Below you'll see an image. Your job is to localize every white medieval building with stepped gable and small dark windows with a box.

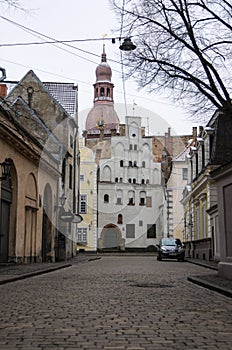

[98,117,166,250]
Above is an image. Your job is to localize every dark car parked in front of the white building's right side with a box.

[156,237,185,261]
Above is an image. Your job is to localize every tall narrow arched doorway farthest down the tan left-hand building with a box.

[42,184,52,262]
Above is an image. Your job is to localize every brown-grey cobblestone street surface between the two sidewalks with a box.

[0,256,232,350]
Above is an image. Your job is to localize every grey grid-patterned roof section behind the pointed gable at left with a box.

[43,82,77,117]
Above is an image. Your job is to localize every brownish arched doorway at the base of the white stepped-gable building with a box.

[101,224,122,250]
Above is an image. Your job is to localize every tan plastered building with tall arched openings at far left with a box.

[0,93,61,263]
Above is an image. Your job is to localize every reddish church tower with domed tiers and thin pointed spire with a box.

[85,44,119,138]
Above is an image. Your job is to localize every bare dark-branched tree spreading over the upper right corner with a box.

[111,0,232,116]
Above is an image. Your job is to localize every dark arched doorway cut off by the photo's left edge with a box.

[0,176,12,262]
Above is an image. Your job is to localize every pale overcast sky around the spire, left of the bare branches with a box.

[0,0,197,134]
